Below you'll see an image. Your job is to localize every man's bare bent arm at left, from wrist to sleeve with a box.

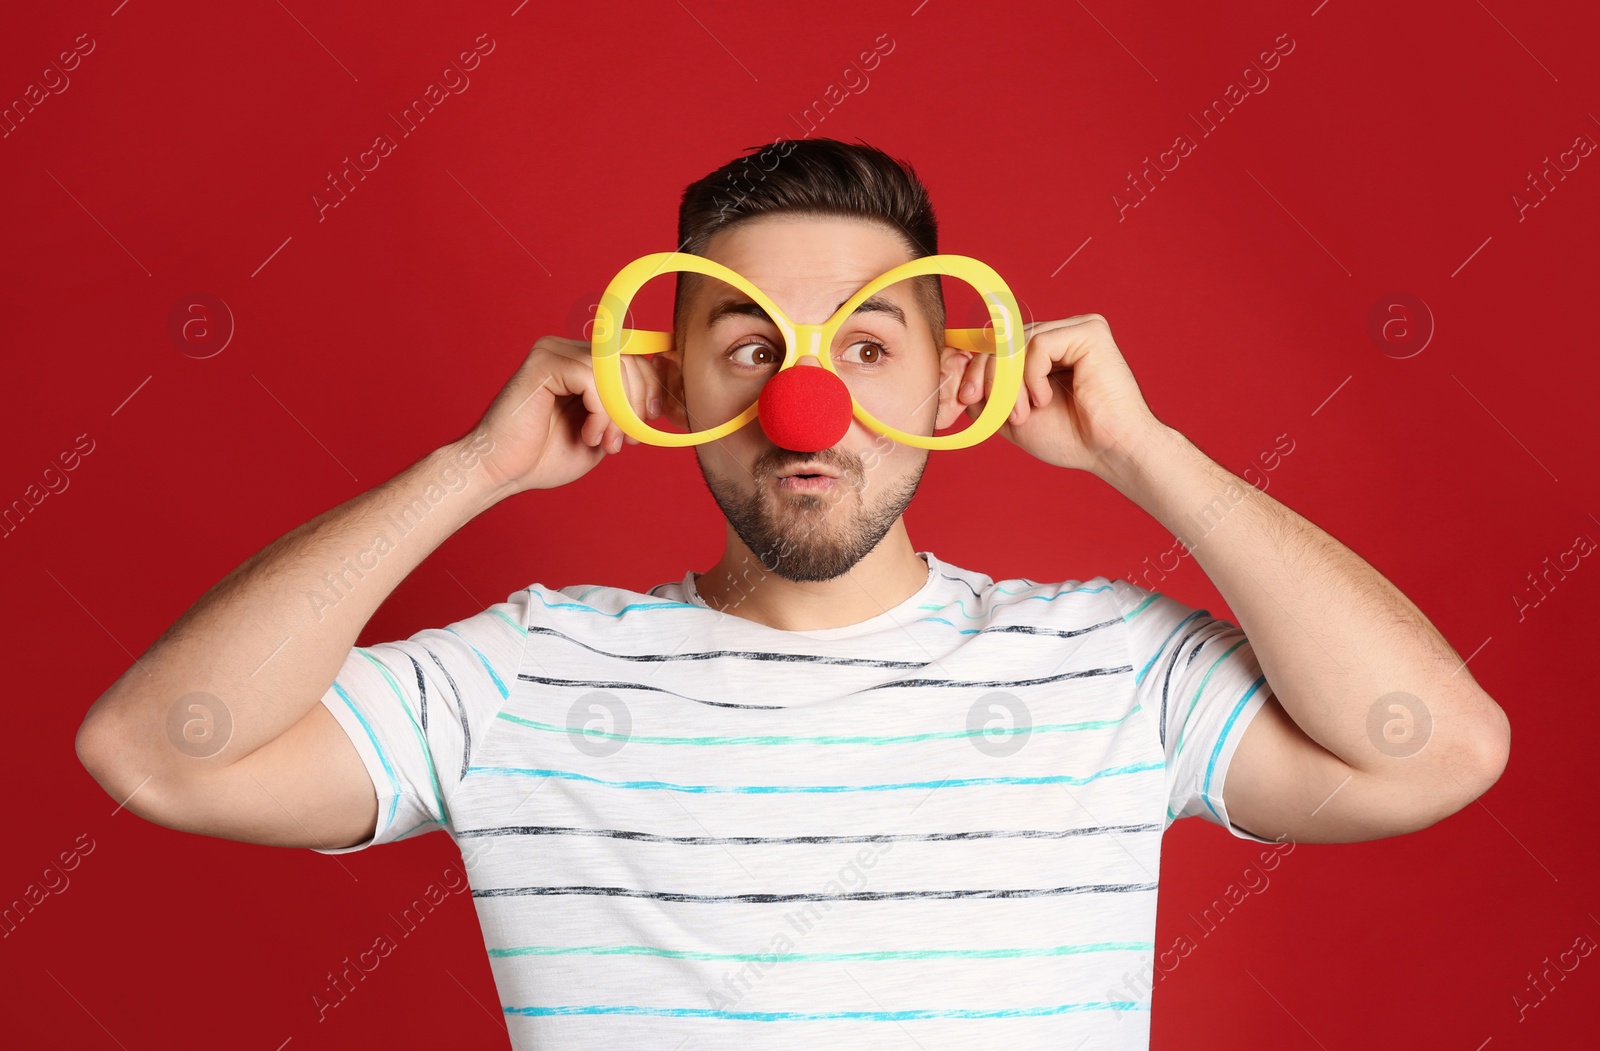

[77,432,501,848]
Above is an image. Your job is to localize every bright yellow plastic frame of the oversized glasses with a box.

[590,251,1024,450]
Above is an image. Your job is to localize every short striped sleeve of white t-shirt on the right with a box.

[1110,581,1274,843]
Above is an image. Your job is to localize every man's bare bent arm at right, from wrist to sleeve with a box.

[1096,418,1510,843]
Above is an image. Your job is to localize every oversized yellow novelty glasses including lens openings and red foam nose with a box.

[592,251,1022,451]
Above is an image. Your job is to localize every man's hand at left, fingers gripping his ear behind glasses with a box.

[475,336,669,496]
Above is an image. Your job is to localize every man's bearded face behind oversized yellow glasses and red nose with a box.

[656,216,965,581]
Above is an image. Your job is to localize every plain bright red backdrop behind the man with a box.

[0,0,1600,1051]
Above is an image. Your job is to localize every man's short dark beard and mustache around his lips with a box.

[694,450,928,582]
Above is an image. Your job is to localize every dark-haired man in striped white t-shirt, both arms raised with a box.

[78,139,1509,1051]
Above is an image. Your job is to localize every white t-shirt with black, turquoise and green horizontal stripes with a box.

[323,552,1270,1051]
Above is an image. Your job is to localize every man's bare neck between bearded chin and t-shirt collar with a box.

[694,522,928,632]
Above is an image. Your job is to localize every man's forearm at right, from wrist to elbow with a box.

[1098,424,1507,781]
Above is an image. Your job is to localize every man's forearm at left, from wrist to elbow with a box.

[80,425,498,771]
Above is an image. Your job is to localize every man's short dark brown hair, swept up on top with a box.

[672,139,944,349]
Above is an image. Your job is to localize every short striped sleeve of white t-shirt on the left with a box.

[312,589,530,854]
